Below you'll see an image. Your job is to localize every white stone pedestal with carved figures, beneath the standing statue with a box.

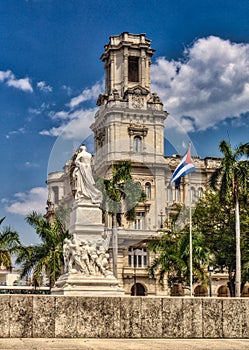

[52,201,124,296]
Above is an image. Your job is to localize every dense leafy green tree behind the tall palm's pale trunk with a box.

[192,190,249,296]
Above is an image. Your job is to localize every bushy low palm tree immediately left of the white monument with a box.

[17,212,69,288]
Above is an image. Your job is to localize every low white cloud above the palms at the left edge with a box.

[2,187,48,216]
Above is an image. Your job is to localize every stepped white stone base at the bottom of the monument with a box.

[51,273,124,296]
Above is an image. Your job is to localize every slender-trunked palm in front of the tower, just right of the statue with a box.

[98,161,146,277]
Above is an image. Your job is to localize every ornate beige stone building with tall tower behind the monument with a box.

[47,32,229,295]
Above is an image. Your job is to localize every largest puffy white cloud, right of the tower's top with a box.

[151,36,249,132]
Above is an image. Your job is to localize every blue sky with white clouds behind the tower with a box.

[0,0,249,244]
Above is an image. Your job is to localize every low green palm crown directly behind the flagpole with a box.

[148,207,210,287]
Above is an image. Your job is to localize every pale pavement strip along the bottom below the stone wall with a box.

[0,338,249,350]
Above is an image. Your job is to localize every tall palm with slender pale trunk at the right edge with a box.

[210,140,249,297]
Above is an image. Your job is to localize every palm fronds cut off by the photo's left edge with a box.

[0,217,21,271]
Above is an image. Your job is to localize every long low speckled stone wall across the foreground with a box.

[0,295,249,339]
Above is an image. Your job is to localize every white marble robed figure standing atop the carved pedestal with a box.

[72,145,102,204]
